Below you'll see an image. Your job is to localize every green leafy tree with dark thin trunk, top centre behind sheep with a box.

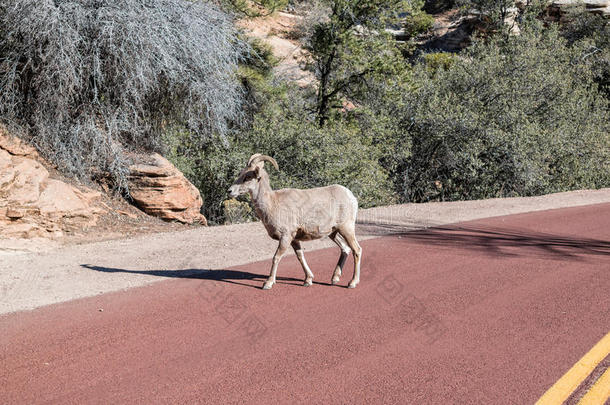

[306,0,414,126]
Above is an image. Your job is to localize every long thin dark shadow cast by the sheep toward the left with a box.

[80,264,330,289]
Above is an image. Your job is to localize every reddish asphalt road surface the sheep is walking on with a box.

[0,204,610,404]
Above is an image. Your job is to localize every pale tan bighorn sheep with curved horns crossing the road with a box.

[229,153,362,290]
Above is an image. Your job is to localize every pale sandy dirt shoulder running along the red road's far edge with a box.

[0,189,610,314]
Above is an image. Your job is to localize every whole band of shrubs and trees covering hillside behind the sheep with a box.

[0,0,610,223]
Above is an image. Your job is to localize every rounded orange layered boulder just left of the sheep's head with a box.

[129,153,207,225]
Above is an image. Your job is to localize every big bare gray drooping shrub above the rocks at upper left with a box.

[0,0,246,190]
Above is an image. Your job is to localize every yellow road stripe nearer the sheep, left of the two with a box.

[536,332,610,405]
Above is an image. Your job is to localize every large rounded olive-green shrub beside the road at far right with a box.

[404,27,610,201]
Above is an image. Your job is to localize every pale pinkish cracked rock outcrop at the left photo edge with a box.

[0,127,105,238]
